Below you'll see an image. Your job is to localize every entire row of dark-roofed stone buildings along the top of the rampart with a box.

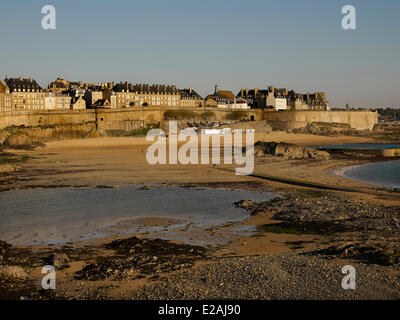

[0,77,329,111]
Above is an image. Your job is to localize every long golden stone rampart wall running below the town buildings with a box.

[0,106,378,131]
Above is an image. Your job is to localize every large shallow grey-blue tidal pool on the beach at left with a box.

[0,186,274,245]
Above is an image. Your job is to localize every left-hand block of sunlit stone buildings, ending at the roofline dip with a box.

[0,77,204,111]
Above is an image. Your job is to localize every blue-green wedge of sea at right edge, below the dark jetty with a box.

[336,160,400,189]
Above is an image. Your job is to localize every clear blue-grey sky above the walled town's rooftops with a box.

[0,0,400,107]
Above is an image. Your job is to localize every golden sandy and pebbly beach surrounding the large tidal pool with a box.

[0,132,400,299]
